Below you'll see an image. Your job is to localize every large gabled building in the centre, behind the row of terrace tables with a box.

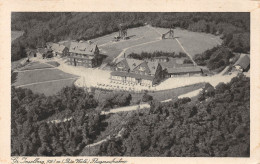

[111,58,164,86]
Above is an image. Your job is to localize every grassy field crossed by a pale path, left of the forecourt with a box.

[12,62,77,96]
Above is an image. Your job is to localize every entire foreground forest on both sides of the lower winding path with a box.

[11,75,250,157]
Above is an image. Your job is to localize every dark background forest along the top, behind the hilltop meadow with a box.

[11,12,250,61]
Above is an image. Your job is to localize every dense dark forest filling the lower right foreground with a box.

[97,75,250,157]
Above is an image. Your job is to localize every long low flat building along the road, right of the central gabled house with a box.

[166,66,203,77]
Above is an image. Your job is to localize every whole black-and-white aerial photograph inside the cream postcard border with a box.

[10,12,250,157]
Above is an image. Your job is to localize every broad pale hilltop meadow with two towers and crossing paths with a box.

[92,26,222,61]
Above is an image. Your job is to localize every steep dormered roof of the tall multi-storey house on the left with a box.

[69,41,98,55]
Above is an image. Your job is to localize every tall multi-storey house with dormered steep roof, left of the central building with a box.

[67,41,102,68]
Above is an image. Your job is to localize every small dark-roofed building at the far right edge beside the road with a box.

[233,54,250,72]
